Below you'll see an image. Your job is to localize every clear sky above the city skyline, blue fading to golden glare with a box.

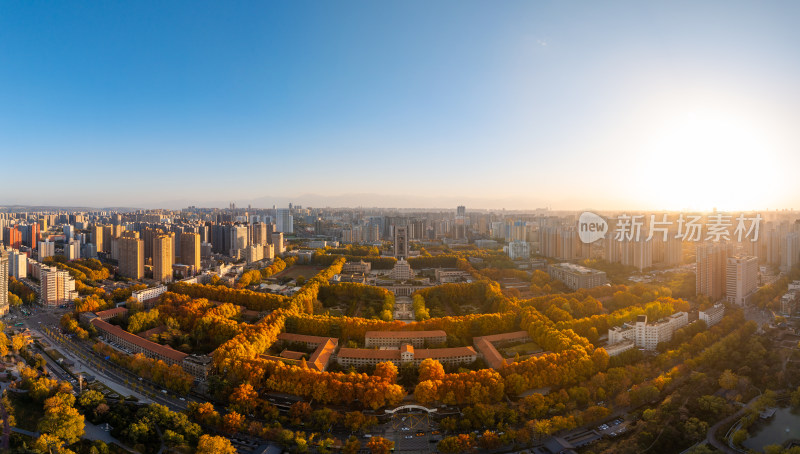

[0,1,800,209]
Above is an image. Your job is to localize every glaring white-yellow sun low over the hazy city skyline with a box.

[637,110,779,211]
